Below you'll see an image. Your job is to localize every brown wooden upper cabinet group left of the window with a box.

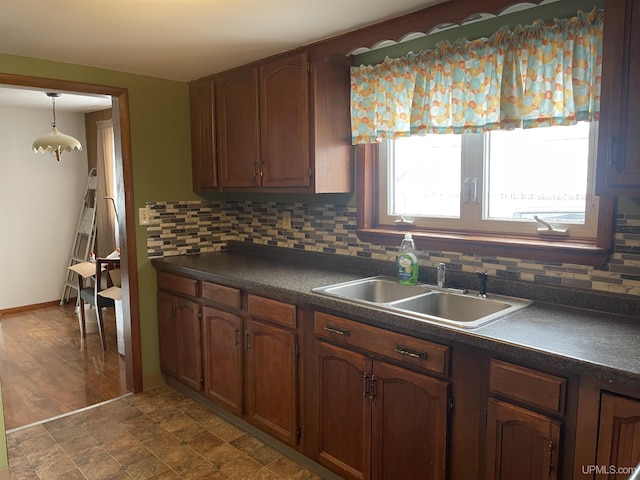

[190,50,353,193]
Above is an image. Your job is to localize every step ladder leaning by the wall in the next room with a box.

[60,168,98,305]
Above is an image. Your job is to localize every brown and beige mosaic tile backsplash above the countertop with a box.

[147,201,640,295]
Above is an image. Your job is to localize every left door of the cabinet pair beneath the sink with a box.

[318,342,370,479]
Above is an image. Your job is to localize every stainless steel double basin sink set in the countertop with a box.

[312,277,531,328]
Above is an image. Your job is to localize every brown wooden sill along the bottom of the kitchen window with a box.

[357,228,610,266]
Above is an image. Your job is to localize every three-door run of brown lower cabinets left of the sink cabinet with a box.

[158,272,300,446]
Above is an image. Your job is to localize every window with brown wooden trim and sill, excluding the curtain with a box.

[357,118,614,266]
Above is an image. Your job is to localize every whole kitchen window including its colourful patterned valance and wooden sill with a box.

[351,2,614,265]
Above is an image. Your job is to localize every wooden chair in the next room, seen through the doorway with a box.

[78,258,120,350]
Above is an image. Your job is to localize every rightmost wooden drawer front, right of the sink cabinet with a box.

[489,360,567,415]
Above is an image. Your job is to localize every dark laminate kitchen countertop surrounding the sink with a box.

[152,248,640,388]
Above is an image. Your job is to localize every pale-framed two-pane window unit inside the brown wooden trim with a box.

[378,122,598,239]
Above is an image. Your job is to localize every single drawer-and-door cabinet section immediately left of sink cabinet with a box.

[245,294,298,446]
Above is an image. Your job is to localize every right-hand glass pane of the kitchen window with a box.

[483,122,589,224]
